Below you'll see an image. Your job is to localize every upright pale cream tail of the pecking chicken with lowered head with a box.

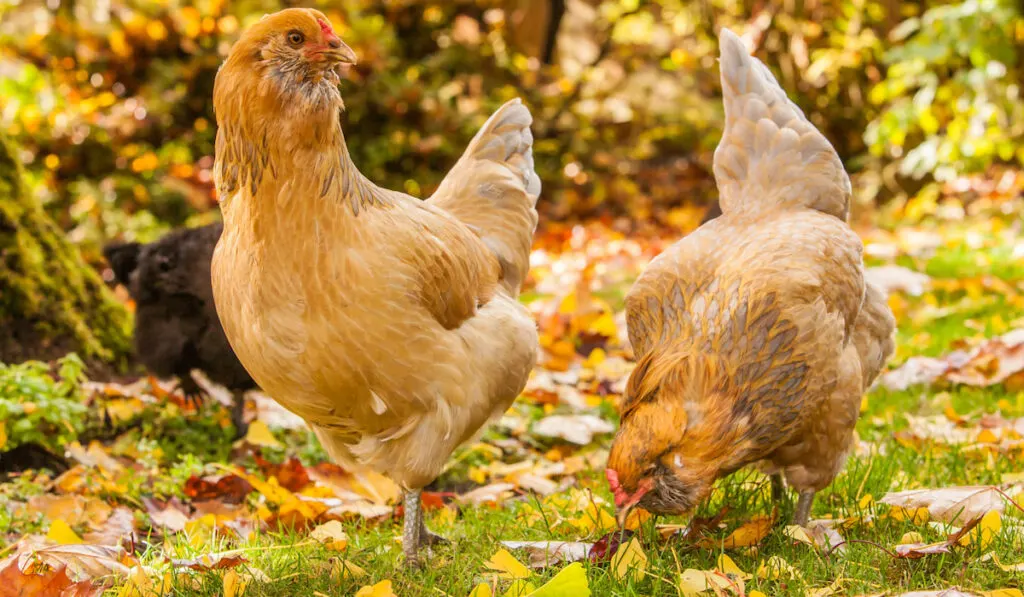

[715,28,852,220]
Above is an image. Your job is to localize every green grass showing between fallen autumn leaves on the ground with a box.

[8,216,1024,597]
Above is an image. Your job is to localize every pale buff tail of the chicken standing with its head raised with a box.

[427,98,541,296]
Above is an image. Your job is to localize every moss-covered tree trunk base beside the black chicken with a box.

[0,136,131,371]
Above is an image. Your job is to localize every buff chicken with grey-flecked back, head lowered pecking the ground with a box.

[606,29,895,524]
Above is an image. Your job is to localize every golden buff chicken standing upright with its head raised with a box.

[212,8,541,565]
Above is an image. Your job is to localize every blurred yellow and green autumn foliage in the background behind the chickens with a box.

[0,0,1024,247]
